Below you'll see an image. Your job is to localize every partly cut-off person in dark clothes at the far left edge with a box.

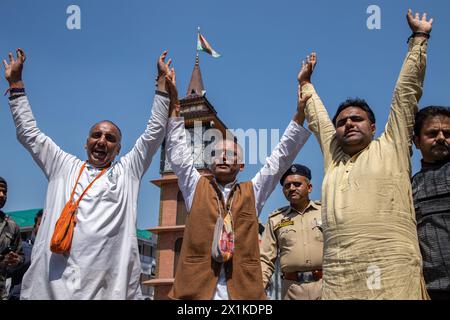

[0,177,24,300]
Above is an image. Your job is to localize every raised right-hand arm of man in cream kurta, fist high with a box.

[384,10,433,153]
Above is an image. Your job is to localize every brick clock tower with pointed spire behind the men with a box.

[144,54,227,300]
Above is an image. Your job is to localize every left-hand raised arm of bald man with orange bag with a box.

[3,49,76,180]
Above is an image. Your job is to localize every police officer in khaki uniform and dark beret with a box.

[261,164,323,300]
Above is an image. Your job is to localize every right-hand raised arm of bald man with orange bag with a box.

[121,51,172,179]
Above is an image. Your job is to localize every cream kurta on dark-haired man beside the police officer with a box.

[303,38,428,299]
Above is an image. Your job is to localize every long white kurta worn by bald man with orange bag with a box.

[5,48,169,299]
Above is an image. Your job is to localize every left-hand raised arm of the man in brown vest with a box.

[166,69,201,212]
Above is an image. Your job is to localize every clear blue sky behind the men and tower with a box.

[0,0,450,228]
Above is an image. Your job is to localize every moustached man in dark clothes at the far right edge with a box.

[412,106,450,300]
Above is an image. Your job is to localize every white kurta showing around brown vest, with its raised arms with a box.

[166,70,310,300]
